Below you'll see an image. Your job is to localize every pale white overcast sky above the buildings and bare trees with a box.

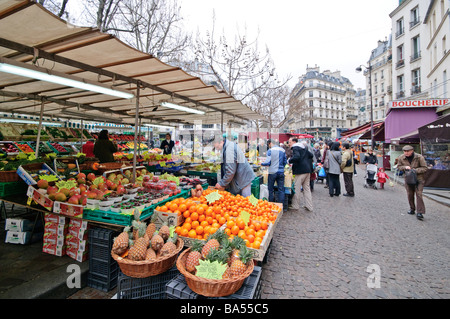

[178,0,398,89]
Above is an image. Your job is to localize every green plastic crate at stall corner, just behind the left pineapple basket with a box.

[83,205,156,226]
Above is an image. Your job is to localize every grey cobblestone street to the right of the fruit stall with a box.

[261,166,450,299]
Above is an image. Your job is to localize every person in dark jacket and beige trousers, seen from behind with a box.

[289,137,314,211]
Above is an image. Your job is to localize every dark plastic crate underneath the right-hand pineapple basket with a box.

[166,266,262,299]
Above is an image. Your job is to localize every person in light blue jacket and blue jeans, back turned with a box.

[261,139,287,204]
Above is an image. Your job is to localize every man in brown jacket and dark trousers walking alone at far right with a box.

[397,145,428,220]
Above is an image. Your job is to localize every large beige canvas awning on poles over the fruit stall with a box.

[0,0,264,125]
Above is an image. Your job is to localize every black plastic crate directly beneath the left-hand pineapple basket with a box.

[117,266,180,299]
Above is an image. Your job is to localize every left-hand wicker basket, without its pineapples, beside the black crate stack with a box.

[111,238,184,278]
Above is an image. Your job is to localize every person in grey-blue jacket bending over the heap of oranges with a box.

[214,134,256,197]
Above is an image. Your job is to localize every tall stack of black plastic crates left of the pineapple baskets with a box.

[87,227,120,292]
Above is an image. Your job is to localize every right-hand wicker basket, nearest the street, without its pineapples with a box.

[177,248,255,297]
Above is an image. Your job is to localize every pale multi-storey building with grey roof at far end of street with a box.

[284,66,358,137]
